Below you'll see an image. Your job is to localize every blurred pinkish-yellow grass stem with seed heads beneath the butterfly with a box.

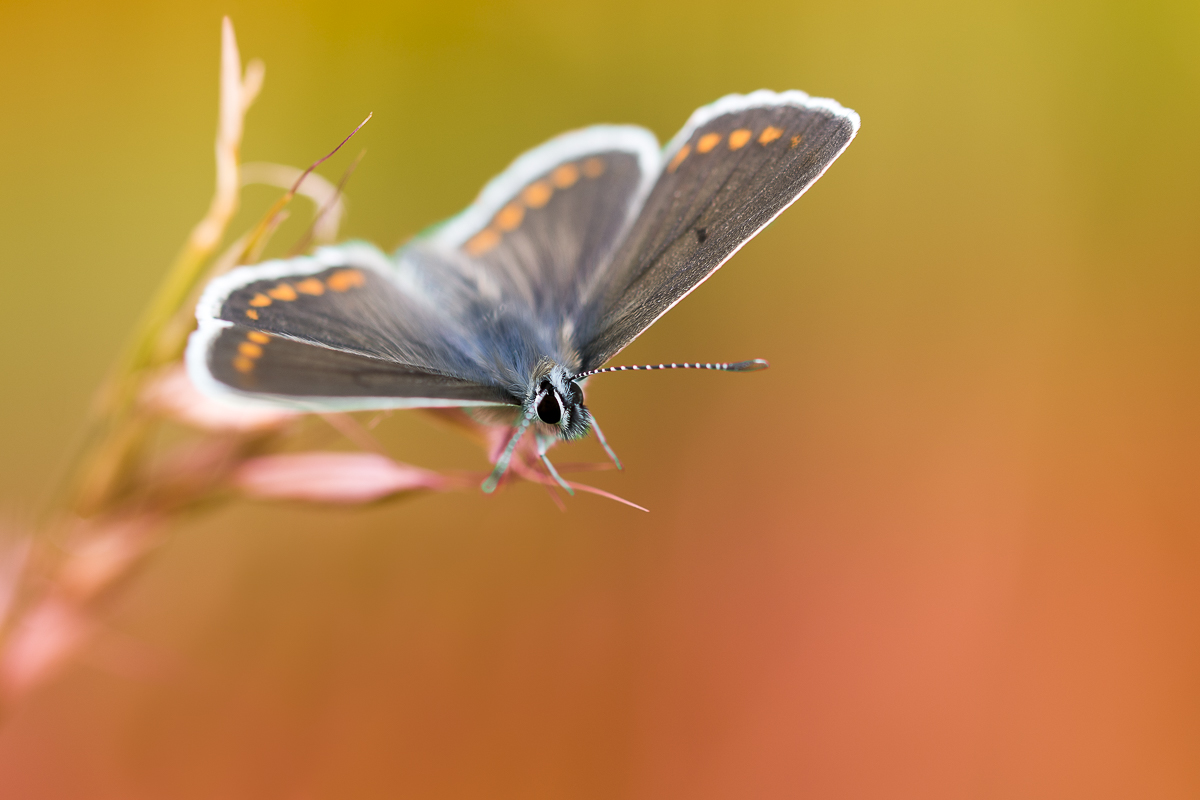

[0,18,638,708]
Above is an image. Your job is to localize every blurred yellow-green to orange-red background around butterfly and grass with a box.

[0,0,1200,799]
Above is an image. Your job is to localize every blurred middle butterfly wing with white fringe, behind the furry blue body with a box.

[398,125,661,381]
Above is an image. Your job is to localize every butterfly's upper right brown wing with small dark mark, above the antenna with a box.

[577,91,859,369]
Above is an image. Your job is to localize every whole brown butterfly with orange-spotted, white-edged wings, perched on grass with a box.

[186,90,859,492]
